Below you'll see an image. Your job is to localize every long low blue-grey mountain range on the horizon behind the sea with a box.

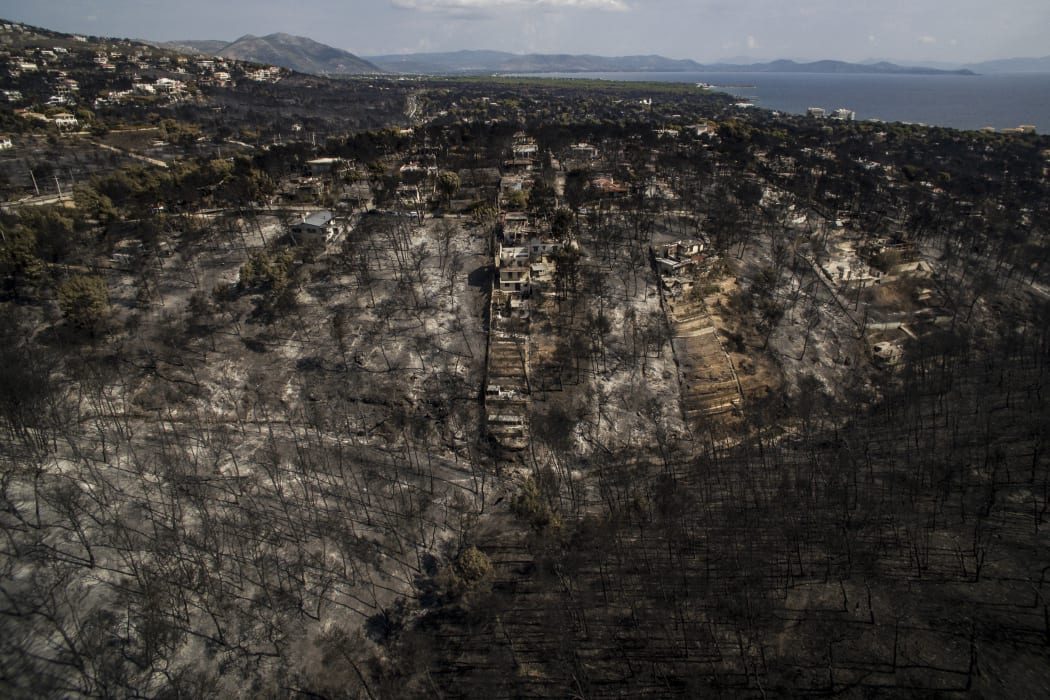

[368,51,972,75]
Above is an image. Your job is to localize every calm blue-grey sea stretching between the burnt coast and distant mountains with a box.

[514,72,1050,133]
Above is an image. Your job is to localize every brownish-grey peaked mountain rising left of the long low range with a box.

[162,34,383,76]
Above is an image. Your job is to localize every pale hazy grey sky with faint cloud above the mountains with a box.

[0,0,1050,62]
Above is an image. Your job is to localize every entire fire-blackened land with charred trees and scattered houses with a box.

[0,16,1050,699]
